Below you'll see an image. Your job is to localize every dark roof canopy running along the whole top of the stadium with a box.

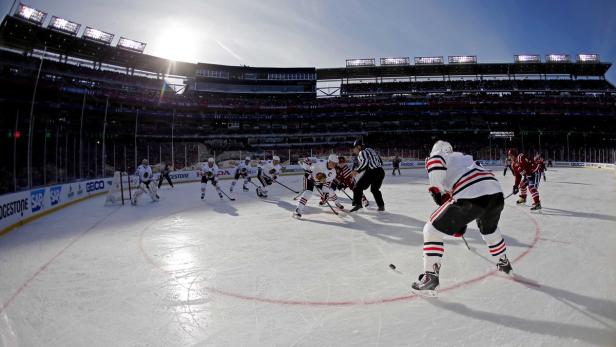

[0,15,612,81]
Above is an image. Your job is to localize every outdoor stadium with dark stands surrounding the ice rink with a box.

[0,4,616,346]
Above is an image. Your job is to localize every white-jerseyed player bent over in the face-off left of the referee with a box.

[293,154,344,218]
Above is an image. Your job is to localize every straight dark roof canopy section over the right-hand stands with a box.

[317,63,612,80]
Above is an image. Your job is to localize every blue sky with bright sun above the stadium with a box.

[0,0,616,82]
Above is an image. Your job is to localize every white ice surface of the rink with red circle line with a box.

[0,168,616,346]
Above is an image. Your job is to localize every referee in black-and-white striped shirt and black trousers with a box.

[350,139,385,212]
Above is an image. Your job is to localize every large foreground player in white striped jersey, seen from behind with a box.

[411,141,512,295]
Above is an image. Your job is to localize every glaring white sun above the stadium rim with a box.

[151,22,197,62]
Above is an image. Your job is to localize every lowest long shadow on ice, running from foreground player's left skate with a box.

[426,299,616,346]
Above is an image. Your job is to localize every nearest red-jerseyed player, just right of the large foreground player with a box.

[508,149,541,211]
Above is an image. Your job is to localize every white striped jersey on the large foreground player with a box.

[426,152,502,199]
